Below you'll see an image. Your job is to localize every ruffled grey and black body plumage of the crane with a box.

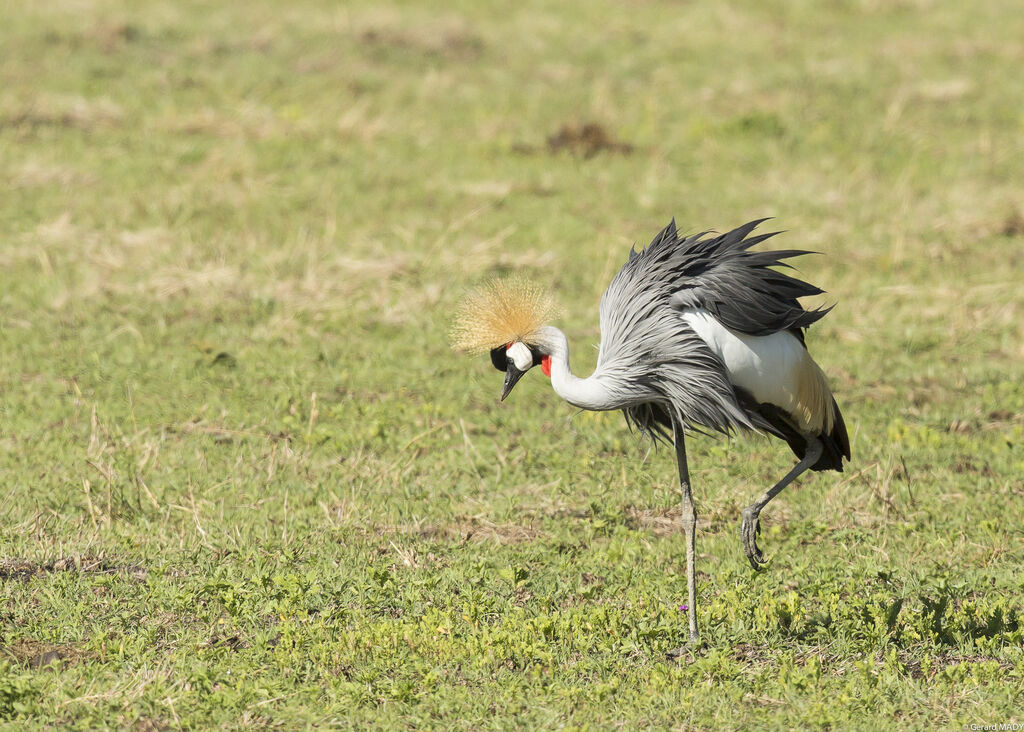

[596,219,850,470]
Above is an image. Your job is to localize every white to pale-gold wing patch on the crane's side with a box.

[682,308,835,433]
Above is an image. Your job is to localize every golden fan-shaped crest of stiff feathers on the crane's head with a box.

[451,276,558,353]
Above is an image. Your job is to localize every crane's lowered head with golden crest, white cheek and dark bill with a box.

[451,277,557,401]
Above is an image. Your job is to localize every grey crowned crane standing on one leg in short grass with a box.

[452,219,850,644]
